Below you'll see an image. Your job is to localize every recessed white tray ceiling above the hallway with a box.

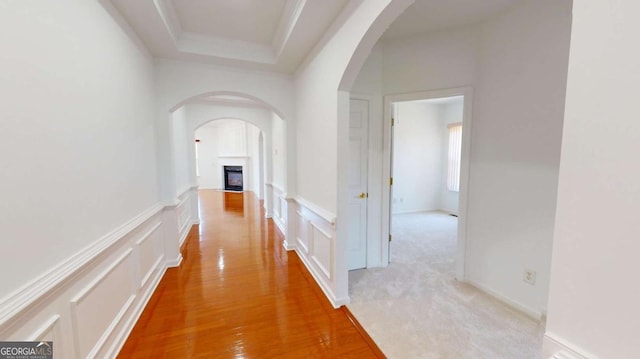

[109,0,350,73]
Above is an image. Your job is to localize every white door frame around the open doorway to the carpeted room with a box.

[381,86,473,281]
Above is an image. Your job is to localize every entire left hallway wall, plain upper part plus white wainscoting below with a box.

[0,0,194,358]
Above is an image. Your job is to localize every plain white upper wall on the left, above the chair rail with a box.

[0,0,158,297]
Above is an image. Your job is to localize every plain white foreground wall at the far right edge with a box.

[544,0,640,358]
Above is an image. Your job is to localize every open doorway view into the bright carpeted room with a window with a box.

[389,95,464,274]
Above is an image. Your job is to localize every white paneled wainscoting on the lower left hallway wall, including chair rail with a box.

[0,200,197,358]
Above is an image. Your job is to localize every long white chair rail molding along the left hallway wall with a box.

[0,204,163,332]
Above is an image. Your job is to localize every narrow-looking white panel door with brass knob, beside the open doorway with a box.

[349,99,369,270]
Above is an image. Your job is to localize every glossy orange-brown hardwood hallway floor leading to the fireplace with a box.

[119,190,384,359]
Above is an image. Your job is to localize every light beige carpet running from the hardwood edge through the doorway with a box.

[348,212,544,359]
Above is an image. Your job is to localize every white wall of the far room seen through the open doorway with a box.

[392,102,444,213]
